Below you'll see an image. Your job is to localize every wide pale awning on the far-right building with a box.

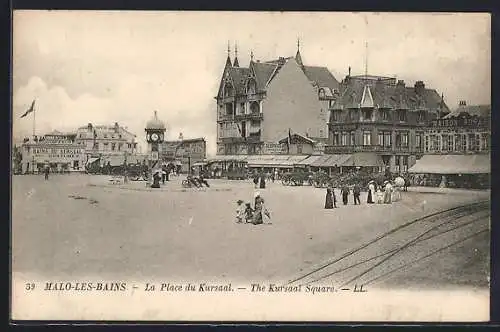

[408,154,491,174]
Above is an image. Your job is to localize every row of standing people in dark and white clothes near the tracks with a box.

[325,180,395,209]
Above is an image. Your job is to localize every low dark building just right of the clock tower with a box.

[161,138,207,173]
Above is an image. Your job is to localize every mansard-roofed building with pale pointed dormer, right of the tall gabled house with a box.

[325,74,449,173]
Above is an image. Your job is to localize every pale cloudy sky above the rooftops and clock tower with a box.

[12,11,491,155]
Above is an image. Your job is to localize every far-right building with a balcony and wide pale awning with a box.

[410,101,491,188]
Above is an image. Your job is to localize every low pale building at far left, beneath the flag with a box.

[21,131,86,174]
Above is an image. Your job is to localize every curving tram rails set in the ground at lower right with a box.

[287,201,490,288]
